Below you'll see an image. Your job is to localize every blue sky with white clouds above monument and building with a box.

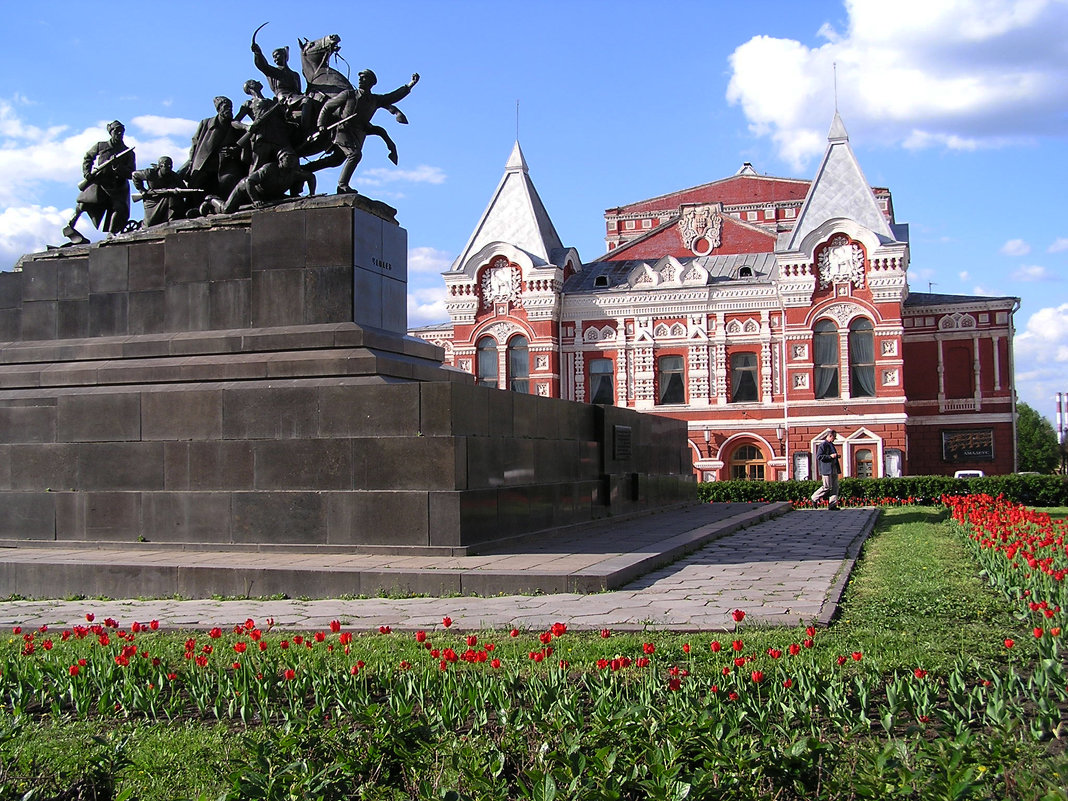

[0,0,1068,427]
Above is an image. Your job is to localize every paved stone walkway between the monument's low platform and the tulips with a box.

[0,508,878,631]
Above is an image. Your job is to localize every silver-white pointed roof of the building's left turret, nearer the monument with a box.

[452,141,563,270]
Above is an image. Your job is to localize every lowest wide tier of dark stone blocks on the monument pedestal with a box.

[0,381,692,549]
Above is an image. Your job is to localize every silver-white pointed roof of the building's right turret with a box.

[787,111,896,250]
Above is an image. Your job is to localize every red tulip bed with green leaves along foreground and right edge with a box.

[0,504,1068,801]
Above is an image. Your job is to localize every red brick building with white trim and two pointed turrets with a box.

[411,114,1019,481]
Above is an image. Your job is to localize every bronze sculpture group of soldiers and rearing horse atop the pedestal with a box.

[57,22,419,245]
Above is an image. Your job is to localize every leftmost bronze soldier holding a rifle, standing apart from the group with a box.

[63,120,137,245]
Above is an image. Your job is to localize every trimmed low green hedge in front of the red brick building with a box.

[697,474,1068,506]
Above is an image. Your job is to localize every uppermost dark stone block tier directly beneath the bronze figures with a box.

[0,198,407,342]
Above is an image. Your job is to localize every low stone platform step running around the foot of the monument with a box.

[0,503,790,598]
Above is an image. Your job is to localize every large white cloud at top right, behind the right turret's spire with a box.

[726,0,1068,169]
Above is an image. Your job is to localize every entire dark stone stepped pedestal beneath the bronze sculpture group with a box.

[0,197,693,568]
